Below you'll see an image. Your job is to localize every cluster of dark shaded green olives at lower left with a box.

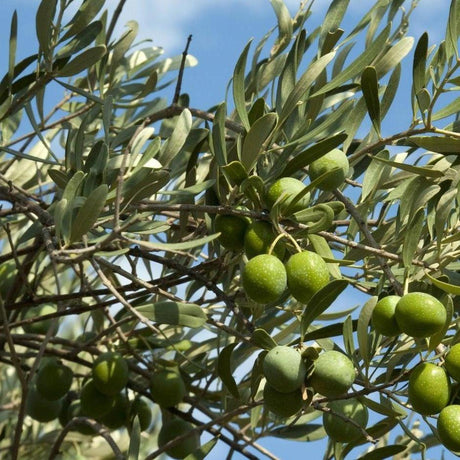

[26,351,200,458]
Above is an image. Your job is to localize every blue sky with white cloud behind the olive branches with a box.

[0,0,453,460]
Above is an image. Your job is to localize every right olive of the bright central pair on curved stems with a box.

[286,251,330,303]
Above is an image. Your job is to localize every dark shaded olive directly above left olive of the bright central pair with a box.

[244,220,286,259]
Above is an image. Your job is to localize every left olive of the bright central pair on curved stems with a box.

[241,254,287,303]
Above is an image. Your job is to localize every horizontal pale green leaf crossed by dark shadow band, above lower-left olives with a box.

[136,301,207,328]
